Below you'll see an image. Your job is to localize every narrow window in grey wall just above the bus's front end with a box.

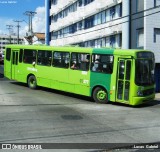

[136,28,144,49]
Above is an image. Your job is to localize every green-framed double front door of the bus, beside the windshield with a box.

[116,59,132,103]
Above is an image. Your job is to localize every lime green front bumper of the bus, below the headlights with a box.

[131,94,155,106]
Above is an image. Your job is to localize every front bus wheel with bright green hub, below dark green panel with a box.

[93,87,108,103]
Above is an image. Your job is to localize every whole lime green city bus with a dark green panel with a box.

[4,45,155,105]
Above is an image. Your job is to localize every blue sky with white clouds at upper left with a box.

[0,0,45,36]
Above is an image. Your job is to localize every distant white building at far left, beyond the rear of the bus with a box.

[0,35,24,54]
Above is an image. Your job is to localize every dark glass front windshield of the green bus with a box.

[135,59,154,85]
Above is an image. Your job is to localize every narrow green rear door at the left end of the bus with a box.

[11,50,18,80]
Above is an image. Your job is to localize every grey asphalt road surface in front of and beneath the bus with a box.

[0,66,160,149]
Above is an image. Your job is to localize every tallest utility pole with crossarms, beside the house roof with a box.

[24,11,37,44]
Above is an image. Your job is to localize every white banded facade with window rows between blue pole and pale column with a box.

[50,0,124,47]
